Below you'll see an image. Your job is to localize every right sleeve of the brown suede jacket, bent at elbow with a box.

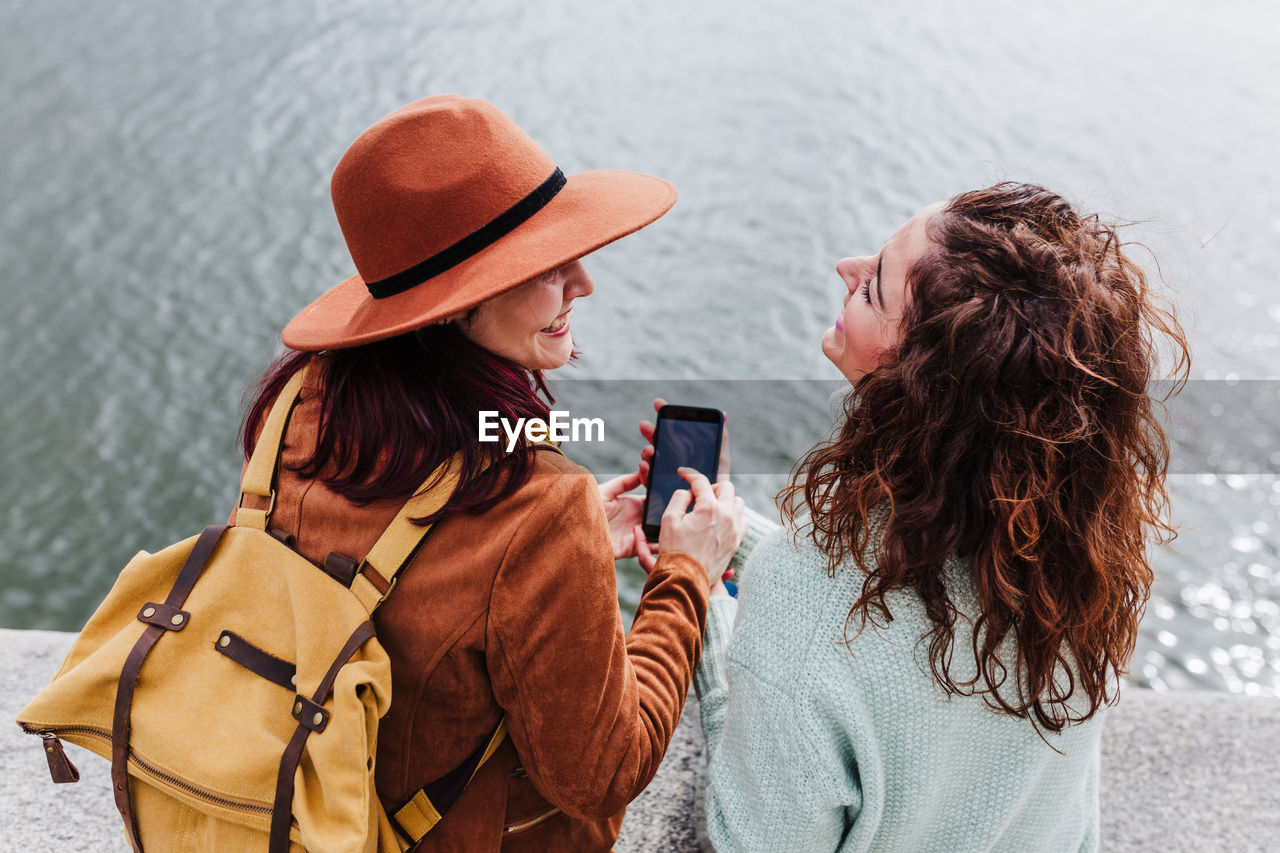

[486,474,707,820]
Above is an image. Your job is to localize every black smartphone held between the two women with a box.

[641,406,724,542]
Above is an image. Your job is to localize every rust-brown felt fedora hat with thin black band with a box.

[282,95,676,351]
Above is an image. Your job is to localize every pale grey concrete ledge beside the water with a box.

[0,629,1280,853]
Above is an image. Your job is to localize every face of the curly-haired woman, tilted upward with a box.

[822,201,943,384]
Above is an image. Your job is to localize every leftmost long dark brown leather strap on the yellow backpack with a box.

[111,525,227,853]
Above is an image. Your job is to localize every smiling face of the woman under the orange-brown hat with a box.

[449,260,595,370]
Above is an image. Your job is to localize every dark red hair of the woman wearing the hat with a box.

[242,324,554,523]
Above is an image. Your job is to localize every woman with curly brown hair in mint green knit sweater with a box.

[695,183,1189,853]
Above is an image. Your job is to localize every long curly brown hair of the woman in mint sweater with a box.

[781,183,1190,731]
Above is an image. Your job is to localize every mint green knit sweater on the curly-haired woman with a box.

[694,532,1101,853]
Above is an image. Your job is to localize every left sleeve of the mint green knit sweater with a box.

[694,558,861,850]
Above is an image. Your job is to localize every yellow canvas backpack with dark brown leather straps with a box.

[18,371,506,853]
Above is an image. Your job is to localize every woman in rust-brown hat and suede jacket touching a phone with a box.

[235,96,741,850]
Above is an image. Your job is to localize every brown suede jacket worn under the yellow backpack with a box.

[233,380,707,852]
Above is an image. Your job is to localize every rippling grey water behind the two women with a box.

[0,0,1280,695]
